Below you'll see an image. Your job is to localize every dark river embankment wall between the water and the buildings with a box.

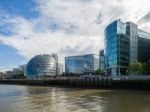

[0,79,150,90]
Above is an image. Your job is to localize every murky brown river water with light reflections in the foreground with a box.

[0,85,150,112]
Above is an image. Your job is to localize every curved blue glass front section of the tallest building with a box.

[105,21,129,76]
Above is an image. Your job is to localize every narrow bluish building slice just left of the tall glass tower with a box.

[99,50,106,70]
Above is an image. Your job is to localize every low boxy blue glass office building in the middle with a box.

[65,54,99,74]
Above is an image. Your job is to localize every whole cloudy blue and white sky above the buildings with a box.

[0,0,150,71]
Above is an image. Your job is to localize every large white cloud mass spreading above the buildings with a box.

[0,0,150,65]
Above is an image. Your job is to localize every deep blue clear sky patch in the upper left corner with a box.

[0,0,38,19]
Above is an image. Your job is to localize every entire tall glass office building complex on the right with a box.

[105,20,150,76]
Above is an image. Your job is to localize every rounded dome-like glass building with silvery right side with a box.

[25,54,58,77]
